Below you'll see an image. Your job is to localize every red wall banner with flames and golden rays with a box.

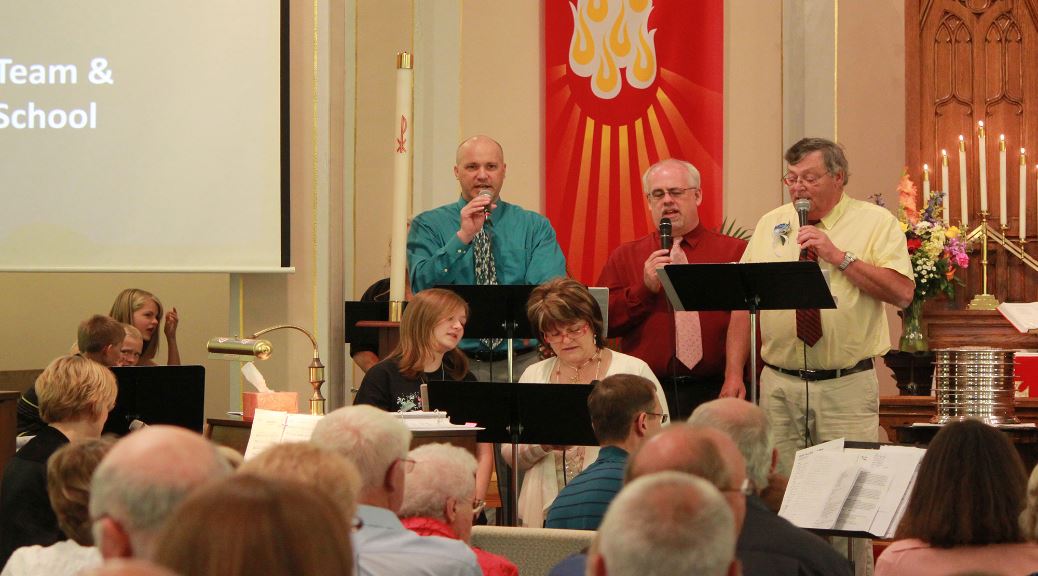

[543,0,725,283]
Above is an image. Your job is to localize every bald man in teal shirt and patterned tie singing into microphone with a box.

[407,136,566,381]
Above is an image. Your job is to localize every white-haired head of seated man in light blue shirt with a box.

[310,405,411,512]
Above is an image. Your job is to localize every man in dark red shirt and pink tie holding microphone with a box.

[598,159,746,420]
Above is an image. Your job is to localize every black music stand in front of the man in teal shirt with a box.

[436,284,537,382]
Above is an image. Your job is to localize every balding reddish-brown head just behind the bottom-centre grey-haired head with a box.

[627,424,748,532]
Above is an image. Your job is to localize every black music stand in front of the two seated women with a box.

[429,380,598,526]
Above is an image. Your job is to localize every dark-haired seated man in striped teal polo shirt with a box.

[545,374,667,530]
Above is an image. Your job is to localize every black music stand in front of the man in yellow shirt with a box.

[659,260,837,404]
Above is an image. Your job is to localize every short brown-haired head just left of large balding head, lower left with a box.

[47,438,114,546]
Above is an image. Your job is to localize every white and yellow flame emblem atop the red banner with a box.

[570,0,657,100]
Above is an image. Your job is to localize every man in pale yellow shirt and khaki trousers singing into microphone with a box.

[720,138,914,474]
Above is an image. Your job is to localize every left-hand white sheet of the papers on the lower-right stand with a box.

[779,439,862,529]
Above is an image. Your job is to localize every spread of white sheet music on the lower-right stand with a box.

[779,438,926,539]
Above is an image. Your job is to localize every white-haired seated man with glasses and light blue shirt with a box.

[310,405,482,576]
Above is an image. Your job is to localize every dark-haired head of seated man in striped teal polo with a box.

[588,374,666,452]
